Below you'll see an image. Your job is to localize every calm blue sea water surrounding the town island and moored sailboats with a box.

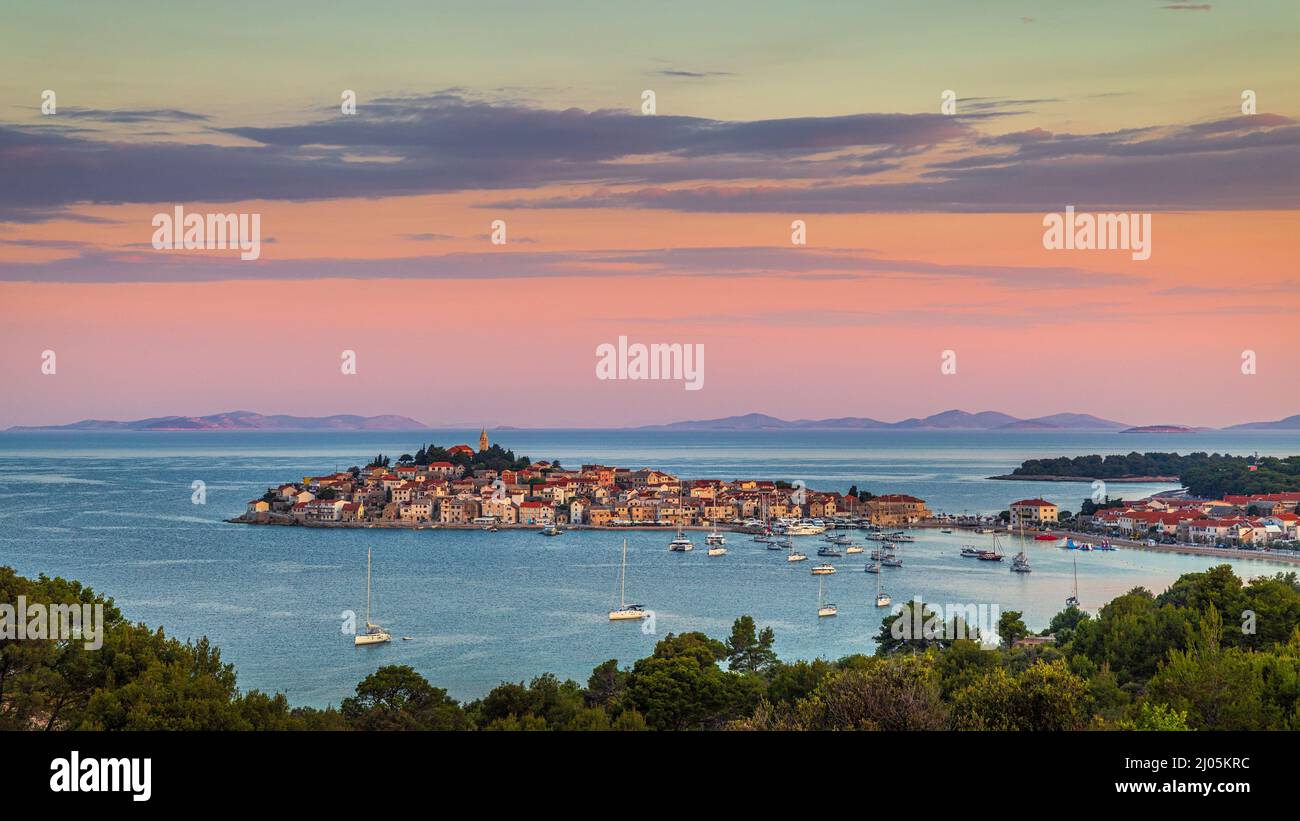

[0,430,1300,705]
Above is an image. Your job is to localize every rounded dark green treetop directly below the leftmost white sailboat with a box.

[339,664,469,730]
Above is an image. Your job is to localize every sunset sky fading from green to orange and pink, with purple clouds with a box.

[0,0,1300,427]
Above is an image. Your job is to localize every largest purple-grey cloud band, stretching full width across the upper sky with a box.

[0,91,1300,222]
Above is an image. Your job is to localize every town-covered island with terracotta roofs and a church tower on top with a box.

[228,430,931,530]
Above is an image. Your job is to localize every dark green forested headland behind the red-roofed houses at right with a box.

[1011,451,1300,499]
